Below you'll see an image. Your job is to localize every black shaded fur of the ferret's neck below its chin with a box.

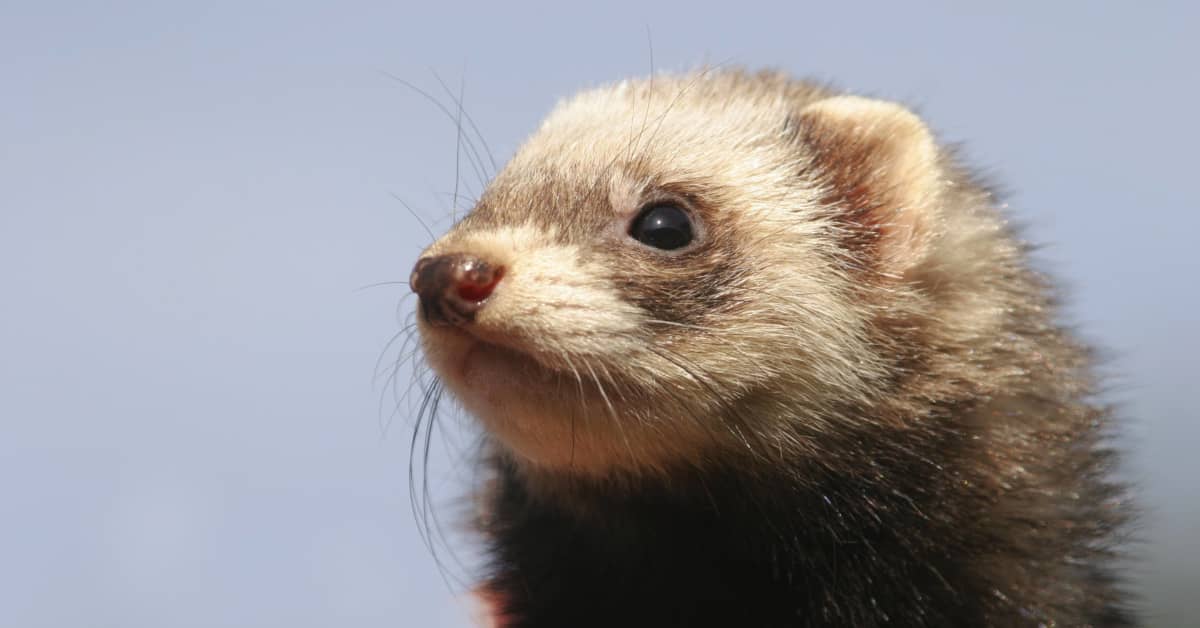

[488,451,985,628]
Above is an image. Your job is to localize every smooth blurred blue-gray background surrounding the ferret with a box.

[0,0,1200,628]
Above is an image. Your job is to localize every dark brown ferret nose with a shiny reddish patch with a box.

[408,253,504,325]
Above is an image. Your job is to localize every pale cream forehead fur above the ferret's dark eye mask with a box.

[497,71,823,192]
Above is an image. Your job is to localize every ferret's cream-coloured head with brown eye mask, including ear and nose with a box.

[412,72,1008,477]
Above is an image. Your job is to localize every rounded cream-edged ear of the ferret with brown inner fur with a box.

[788,96,941,275]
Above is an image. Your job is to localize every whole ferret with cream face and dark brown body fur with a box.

[410,70,1136,628]
